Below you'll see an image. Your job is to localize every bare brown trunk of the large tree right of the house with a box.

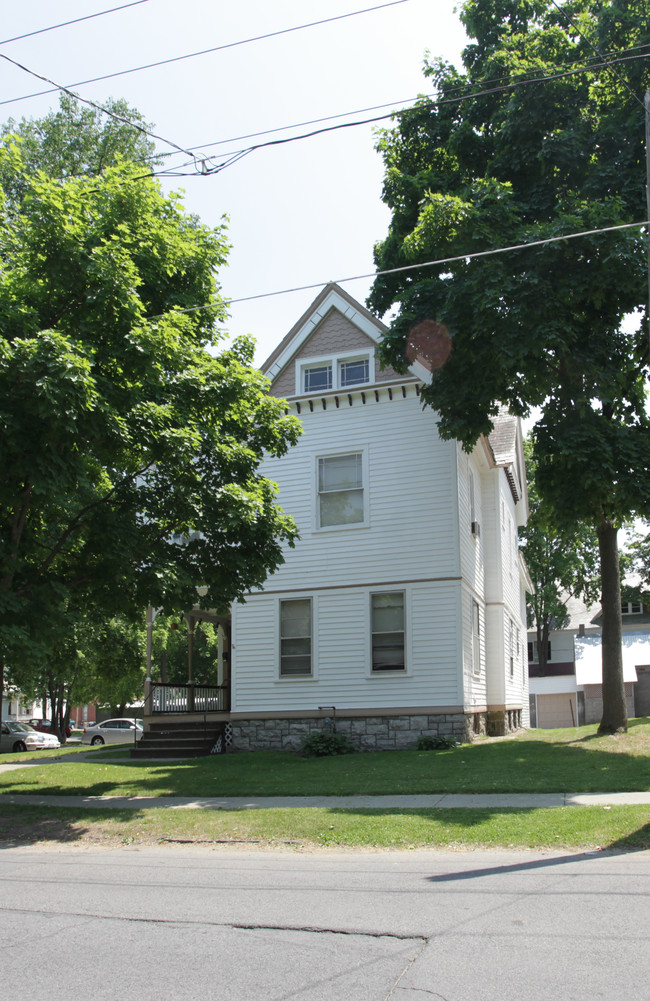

[598,515,627,734]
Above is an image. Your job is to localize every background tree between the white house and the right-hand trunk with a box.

[520,441,600,673]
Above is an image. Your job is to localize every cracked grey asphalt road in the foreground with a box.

[0,847,650,1001]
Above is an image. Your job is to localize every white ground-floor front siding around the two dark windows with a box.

[232,582,463,713]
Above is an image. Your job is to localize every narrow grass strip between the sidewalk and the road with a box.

[0,805,650,850]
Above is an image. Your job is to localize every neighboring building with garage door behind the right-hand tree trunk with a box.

[528,598,650,729]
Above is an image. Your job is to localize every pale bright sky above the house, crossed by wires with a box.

[0,0,465,362]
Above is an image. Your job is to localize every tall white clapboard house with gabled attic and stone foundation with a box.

[145,285,530,749]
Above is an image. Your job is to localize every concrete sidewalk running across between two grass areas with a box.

[0,793,650,810]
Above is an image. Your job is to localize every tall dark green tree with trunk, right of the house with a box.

[369,0,650,733]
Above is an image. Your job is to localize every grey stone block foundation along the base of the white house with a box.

[228,711,521,751]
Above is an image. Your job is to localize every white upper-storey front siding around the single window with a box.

[260,387,458,594]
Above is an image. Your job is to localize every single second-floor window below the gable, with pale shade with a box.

[317,451,366,529]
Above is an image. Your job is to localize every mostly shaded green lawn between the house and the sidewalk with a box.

[0,719,650,796]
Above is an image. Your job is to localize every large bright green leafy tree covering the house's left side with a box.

[0,141,298,712]
